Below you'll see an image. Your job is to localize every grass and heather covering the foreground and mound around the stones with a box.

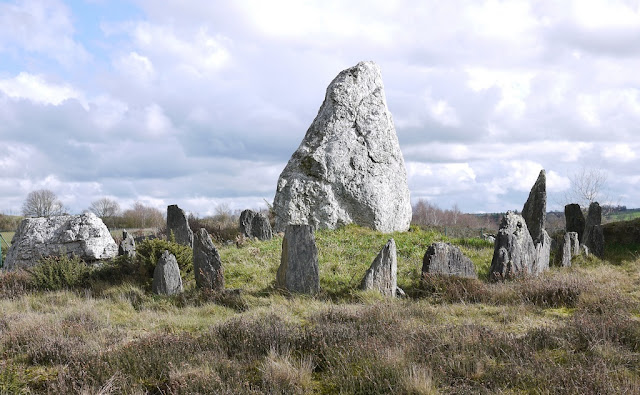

[0,226,640,394]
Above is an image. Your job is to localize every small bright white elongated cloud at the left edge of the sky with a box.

[0,72,88,109]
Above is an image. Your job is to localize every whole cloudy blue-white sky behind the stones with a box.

[0,0,640,216]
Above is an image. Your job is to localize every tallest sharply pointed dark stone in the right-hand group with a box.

[522,169,551,275]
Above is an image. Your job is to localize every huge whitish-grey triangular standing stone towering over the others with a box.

[273,62,411,232]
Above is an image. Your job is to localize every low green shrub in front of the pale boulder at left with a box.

[27,255,92,291]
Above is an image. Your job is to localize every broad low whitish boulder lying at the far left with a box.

[5,213,118,270]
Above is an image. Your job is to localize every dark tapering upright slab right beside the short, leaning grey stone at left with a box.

[193,228,224,290]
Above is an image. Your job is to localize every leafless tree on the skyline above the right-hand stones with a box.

[565,167,608,207]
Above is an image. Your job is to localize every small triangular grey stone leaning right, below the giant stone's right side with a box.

[360,239,398,296]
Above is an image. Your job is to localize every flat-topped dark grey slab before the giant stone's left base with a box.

[276,225,320,294]
